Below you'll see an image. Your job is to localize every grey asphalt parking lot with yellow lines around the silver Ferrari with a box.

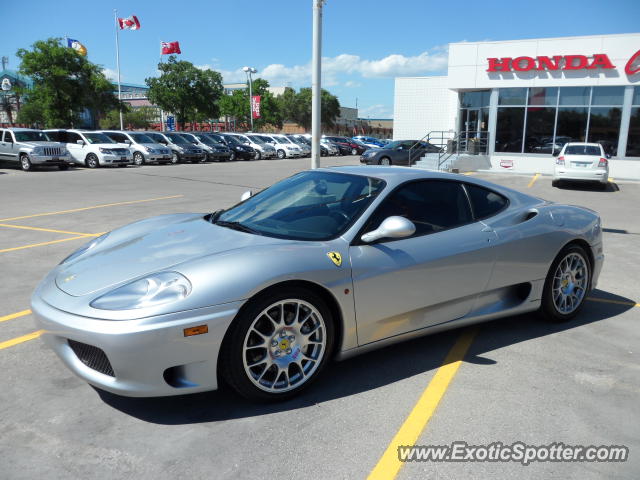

[0,157,640,479]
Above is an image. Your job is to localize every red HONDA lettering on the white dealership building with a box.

[487,53,616,72]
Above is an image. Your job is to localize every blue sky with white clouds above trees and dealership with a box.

[0,0,640,118]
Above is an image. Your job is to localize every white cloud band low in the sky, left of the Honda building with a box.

[196,46,448,87]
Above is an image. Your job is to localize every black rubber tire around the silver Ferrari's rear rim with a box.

[538,244,593,322]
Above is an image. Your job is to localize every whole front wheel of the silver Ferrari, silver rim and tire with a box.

[221,288,334,401]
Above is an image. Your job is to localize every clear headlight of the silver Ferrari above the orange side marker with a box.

[91,272,191,310]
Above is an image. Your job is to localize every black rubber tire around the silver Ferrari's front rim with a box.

[220,287,335,402]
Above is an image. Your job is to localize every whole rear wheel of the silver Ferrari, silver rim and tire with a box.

[540,244,591,322]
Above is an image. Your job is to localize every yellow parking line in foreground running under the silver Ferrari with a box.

[367,330,476,480]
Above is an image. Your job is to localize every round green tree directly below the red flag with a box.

[145,55,223,129]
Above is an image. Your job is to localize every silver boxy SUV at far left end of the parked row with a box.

[0,128,72,172]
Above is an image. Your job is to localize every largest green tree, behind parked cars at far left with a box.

[16,38,120,127]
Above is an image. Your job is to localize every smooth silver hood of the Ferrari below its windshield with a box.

[56,214,292,296]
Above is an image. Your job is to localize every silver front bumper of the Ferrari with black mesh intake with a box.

[31,293,242,397]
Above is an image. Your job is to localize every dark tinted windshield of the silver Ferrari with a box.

[214,171,385,240]
